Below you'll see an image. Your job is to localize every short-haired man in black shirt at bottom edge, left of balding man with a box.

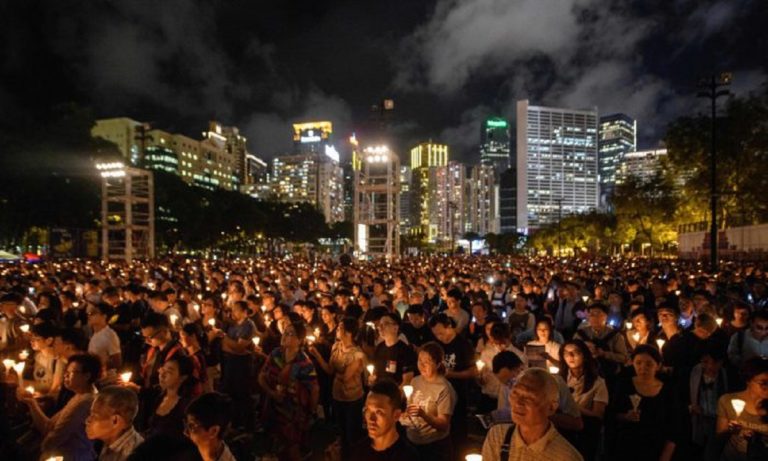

[348,379,419,461]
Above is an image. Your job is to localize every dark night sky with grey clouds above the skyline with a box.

[0,0,768,161]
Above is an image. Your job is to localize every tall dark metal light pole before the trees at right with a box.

[697,72,732,272]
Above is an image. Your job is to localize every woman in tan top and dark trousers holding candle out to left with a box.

[308,317,365,454]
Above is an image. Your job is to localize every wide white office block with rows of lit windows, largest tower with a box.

[516,100,598,233]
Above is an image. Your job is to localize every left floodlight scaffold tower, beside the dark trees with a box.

[96,162,155,262]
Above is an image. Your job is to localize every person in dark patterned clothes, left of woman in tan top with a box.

[259,320,320,461]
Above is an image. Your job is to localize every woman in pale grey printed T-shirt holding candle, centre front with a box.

[400,342,457,461]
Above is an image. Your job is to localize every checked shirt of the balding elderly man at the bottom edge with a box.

[483,424,584,461]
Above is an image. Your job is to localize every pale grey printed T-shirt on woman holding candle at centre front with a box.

[400,376,456,445]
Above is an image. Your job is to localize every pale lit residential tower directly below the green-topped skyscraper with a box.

[467,165,499,235]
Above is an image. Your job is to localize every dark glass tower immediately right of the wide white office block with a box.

[598,114,637,209]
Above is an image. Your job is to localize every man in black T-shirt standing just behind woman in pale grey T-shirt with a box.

[372,313,416,384]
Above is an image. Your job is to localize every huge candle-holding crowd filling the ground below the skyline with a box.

[0,256,768,461]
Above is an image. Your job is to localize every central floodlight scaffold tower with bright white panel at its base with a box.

[352,144,400,259]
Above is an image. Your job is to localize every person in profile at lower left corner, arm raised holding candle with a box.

[18,354,101,461]
